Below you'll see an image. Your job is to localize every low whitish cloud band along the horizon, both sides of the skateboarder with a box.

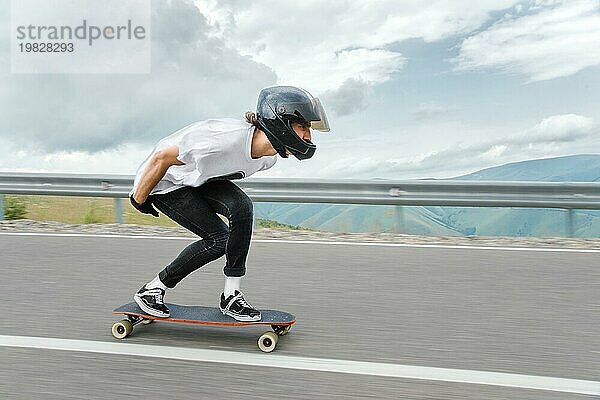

[0,114,600,179]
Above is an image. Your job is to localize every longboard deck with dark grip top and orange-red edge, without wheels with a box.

[113,303,296,326]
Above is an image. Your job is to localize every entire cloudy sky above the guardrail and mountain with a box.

[0,0,600,179]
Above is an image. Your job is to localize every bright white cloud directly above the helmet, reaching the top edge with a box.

[197,0,515,93]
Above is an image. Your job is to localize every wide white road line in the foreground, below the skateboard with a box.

[0,335,600,395]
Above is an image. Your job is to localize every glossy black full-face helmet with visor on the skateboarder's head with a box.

[256,86,329,160]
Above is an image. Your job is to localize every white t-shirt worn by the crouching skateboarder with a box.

[129,118,277,195]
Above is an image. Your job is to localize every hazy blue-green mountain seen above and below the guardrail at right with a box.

[255,154,600,237]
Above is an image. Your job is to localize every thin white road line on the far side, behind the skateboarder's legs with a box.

[0,232,600,253]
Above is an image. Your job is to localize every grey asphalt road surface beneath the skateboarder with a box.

[0,235,600,399]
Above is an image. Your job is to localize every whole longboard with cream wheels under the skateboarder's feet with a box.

[112,303,296,353]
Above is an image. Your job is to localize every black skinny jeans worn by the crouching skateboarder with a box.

[152,180,253,288]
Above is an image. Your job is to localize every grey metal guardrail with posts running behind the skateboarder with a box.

[0,172,600,231]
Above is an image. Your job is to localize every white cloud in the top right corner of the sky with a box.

[453,0,600,81]
